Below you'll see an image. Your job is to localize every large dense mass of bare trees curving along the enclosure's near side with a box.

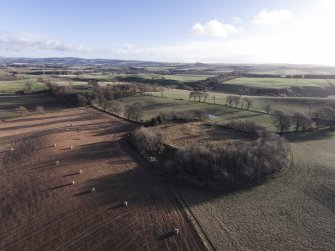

[170,128,289,189]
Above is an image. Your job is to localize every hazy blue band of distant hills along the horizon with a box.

[0,57,335,77]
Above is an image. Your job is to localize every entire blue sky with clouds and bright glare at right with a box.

[0,0,335,66]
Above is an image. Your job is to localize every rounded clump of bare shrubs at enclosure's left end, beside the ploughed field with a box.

[130,127,164,156]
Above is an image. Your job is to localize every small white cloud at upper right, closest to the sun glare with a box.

[252,9,293,26]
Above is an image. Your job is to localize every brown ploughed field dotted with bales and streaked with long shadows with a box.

[0,108,205,250]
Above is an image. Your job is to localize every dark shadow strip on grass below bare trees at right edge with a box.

[285,128,335,143]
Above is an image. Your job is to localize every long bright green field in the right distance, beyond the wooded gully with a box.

[225,78,330,89]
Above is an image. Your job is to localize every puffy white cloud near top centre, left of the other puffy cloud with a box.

[192,19,239,38]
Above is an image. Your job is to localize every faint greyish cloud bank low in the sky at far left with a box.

[0,32,94,53]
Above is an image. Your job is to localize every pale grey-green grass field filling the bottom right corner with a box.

[179,133,335,250]
